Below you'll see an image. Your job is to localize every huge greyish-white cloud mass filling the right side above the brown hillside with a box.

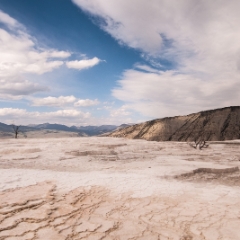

[72,0,240,117]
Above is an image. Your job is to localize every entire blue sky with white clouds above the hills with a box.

[0,0,240,126]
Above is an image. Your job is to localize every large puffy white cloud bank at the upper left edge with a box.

[0,10,71,99]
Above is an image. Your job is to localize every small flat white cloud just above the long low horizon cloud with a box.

[32,95,77,107]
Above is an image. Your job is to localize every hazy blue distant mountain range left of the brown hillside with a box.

[0,123,133,137]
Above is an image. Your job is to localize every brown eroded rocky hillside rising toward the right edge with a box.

[108,106,240,142]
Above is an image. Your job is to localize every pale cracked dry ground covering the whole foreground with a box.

[0,137,240,240]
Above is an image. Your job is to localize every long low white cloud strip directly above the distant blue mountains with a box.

[0,108,91,125]
